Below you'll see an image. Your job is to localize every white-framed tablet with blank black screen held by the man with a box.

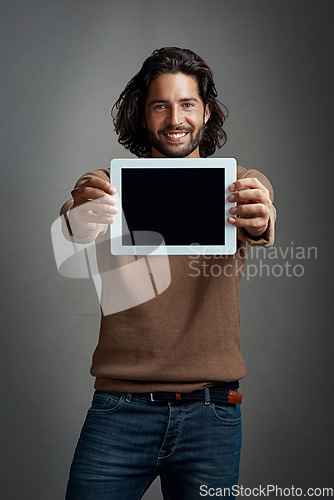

[110,158,237,255]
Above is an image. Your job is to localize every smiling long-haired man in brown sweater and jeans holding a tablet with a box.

[61,47,275,500]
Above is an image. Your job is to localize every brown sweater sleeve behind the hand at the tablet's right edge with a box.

[238,166,276,247]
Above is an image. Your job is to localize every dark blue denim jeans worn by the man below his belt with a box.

[66,389,241,500]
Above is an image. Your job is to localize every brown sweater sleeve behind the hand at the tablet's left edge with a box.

[60,169,110,243]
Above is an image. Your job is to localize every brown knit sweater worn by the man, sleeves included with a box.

[61,167,276,392]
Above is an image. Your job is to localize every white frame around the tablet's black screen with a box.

[110,158,237,255]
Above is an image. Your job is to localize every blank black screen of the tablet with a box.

[121,167,225,246]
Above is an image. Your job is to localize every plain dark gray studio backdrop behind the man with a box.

[0,0,334,500]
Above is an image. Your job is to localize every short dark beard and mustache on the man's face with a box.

[147,123,205,158]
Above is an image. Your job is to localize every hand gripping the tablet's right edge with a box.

[227,177,272,238]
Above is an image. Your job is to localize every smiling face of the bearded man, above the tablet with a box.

[143,73,211,158]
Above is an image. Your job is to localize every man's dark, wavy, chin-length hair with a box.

[111,47,228,158]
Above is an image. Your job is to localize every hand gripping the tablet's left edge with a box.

[68,177,118,238]
